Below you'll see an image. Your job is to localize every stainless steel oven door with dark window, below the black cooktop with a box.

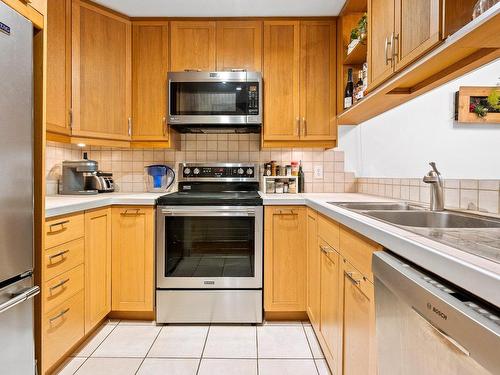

[156,206,263,289]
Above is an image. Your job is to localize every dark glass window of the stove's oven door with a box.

[165,217,255,277]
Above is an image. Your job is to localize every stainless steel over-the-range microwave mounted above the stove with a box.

[167,71,262,133]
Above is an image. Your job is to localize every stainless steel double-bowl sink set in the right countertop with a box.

[329,202,500,229]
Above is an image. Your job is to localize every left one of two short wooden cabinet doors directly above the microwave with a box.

[170,21,216,72]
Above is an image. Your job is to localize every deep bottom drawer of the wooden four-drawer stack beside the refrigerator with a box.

[42,290,84,369]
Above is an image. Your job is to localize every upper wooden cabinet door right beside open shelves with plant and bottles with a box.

[368,0,395,89]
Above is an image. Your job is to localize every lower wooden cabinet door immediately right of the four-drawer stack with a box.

[85,208,111,333]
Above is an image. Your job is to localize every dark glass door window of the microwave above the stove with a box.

[170,82,248,116]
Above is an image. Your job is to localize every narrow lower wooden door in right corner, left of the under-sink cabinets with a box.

[307,208,321,330]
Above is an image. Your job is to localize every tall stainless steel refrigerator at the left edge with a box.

[0,1,40,375]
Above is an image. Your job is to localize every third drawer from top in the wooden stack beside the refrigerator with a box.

[44,264,84,312]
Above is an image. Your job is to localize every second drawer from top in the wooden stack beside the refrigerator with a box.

[44,238,84,281]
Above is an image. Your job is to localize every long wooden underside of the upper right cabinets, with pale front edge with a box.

[337,4,500,125]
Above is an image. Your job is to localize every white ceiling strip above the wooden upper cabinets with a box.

[96,0,345,17]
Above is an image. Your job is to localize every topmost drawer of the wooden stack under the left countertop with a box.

[45,213,84,249]
